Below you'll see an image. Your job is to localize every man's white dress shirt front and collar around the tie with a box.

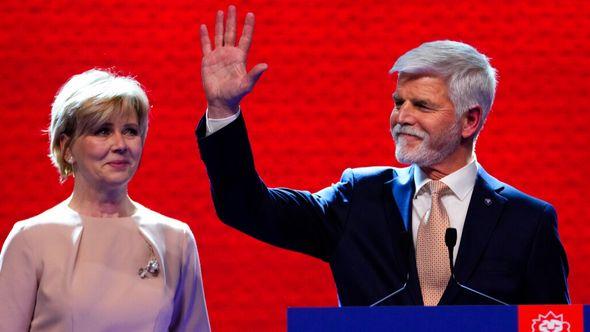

[412,156,477,262]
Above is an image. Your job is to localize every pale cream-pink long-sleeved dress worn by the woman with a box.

[0,201,210,332]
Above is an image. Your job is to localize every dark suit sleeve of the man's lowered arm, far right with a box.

[525,204,570,304]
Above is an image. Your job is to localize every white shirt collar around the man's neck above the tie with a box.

[413,155,478,200]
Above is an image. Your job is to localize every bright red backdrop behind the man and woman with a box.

[0,0,590,331]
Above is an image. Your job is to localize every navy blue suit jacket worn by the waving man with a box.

[196,116,569,305]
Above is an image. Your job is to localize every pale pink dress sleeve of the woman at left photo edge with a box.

[0,223,38,332]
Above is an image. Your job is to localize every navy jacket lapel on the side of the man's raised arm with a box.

[383,167,422,304]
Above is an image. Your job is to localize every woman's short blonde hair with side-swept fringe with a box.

[48,69,150,182]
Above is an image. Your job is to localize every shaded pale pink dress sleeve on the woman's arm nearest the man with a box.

[170,226,211,332]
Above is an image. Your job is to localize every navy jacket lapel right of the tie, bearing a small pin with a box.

[440,166,506,304]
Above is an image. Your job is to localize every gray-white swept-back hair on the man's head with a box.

[389,40,497,133]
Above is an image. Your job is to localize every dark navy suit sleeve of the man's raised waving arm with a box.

[196,116,353,261]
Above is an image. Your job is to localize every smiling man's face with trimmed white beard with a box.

[390,74,461,167]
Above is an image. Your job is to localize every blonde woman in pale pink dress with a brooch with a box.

[0,70,210,332]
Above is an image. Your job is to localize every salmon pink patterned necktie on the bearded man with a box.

[416,180,451,306]
